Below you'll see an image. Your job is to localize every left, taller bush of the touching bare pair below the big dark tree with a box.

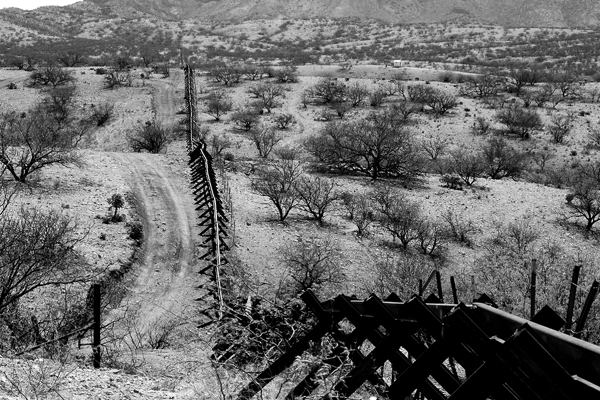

[252,159,302,222]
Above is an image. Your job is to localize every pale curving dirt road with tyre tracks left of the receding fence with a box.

[112,71,198,329]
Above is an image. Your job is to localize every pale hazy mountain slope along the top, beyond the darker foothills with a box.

[85,0,600,27]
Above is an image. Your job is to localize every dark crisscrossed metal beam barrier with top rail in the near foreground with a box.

[238,284,600,400]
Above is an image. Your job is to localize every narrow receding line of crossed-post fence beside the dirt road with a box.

[183,64,228,324]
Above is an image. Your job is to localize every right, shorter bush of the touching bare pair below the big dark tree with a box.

[296,175,340,224]
